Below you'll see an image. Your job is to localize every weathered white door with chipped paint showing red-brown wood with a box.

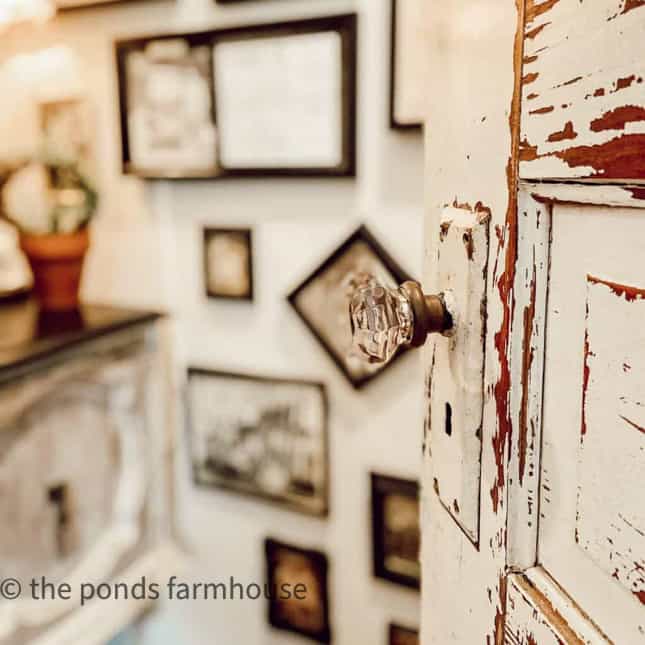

[422,0,645,645]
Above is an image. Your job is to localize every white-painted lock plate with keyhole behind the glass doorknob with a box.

[429,206,490,543]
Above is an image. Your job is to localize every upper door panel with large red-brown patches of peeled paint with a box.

[520,0,645,179]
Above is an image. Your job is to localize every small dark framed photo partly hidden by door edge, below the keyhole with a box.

[371,473,421,589]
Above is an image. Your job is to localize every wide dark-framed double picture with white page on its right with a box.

[115,14,357,179]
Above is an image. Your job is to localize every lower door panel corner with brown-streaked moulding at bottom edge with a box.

[504,568,610,645]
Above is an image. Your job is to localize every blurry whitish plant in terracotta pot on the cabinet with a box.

[1,157,97,311]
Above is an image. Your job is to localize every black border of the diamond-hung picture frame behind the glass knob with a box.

[287,225,411,389]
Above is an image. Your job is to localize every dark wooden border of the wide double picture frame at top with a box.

[115,14,357,179]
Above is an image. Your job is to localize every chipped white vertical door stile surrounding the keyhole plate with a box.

[421,0,521,645]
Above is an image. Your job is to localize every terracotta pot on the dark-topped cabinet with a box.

[20,228,90,311]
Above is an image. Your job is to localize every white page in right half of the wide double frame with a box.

[213,31,343,170]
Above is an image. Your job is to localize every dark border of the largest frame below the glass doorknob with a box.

[185,367,330,518]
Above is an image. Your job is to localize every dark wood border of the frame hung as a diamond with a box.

[287,225,411,389]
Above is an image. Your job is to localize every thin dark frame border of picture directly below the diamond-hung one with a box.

[185,367,330,518]
